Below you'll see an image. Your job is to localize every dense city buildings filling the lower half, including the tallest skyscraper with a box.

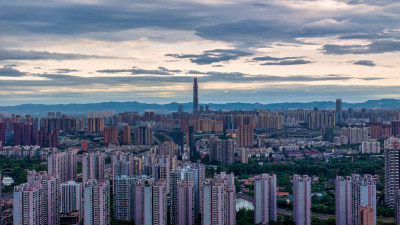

[0,78,400,225]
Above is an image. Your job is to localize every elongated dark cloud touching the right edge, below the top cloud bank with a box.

[322,40,400,55]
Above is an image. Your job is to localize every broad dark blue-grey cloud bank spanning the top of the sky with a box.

[0,1,398,49]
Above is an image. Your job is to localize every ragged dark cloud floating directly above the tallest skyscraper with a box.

[166,49,253,65]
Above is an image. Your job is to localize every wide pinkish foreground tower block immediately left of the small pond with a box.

[200,173,236,225]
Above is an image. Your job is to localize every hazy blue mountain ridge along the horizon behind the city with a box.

[0,99,400,115]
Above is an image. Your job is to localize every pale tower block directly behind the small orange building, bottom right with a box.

[351,174,377,225]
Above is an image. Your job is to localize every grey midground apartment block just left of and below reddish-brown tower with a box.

[209,137,235,165]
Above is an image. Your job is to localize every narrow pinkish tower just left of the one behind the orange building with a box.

[335,176,352,225]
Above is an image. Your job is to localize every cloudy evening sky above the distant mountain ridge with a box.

[0,0,400,105]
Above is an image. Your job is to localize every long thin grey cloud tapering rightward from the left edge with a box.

[0,49,111,60]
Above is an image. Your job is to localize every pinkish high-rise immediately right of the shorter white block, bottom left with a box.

[83,179,110,225]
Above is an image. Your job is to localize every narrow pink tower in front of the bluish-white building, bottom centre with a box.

[177,180,195,225]
